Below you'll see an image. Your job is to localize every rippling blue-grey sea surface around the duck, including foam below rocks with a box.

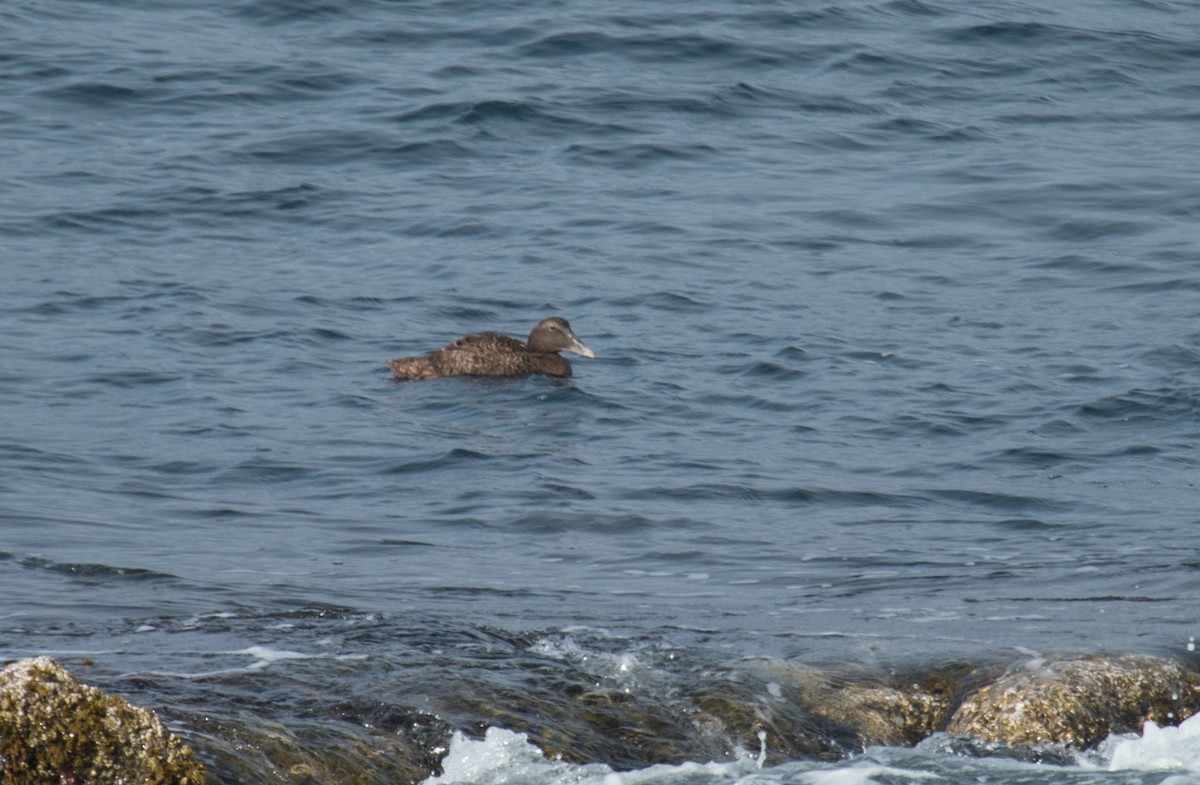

[0,0,1200,785]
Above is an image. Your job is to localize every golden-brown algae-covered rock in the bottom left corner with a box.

[0,657,205,785]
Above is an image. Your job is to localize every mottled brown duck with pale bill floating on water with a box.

[388,316,595,382]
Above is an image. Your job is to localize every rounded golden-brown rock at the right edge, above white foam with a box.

[946,654,1200,749]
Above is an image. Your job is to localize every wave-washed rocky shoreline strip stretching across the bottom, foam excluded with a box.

[9,654,1200,785]
